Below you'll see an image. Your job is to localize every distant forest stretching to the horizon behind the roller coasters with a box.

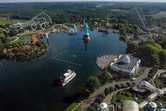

[0,2,166,24]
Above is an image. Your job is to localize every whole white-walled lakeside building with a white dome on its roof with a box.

[110,55,141,75]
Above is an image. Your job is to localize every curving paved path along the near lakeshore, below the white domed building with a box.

[81,68,150,111]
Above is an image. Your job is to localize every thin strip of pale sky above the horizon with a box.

[0,0,166,3]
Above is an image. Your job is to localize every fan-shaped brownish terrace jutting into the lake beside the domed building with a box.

[96,54,118,70]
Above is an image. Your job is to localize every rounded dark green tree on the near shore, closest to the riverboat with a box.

[85,76,101,92]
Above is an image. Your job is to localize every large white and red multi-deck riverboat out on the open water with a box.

[60,70,76,86]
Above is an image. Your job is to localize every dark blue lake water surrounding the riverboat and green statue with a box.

[0,30,126,111]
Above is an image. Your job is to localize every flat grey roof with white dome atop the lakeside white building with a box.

[112,55,139,71]
